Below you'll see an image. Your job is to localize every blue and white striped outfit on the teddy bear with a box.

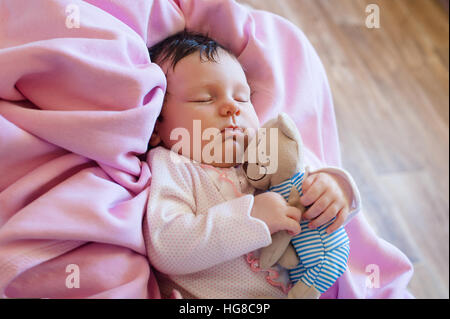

[269,172,350,293]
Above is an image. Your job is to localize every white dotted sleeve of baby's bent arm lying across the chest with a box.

[144,152,271,275]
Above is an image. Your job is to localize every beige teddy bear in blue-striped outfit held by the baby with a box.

[243,113,350,299]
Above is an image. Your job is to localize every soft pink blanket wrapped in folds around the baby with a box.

[0,0,412,298]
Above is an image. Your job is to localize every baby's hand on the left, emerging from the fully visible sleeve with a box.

[250,192,302,235]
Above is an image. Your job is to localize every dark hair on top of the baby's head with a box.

[148,30,234,68]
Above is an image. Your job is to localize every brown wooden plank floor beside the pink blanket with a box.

[239,0,449,298]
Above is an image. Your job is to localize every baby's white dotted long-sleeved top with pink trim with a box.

[144,147,362,298]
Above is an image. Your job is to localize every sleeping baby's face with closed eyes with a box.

[157,49,259,167]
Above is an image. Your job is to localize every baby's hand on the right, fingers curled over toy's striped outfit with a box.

[300,172,351,233]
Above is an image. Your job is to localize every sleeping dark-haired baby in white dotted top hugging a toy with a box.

[144,31,358,298]
